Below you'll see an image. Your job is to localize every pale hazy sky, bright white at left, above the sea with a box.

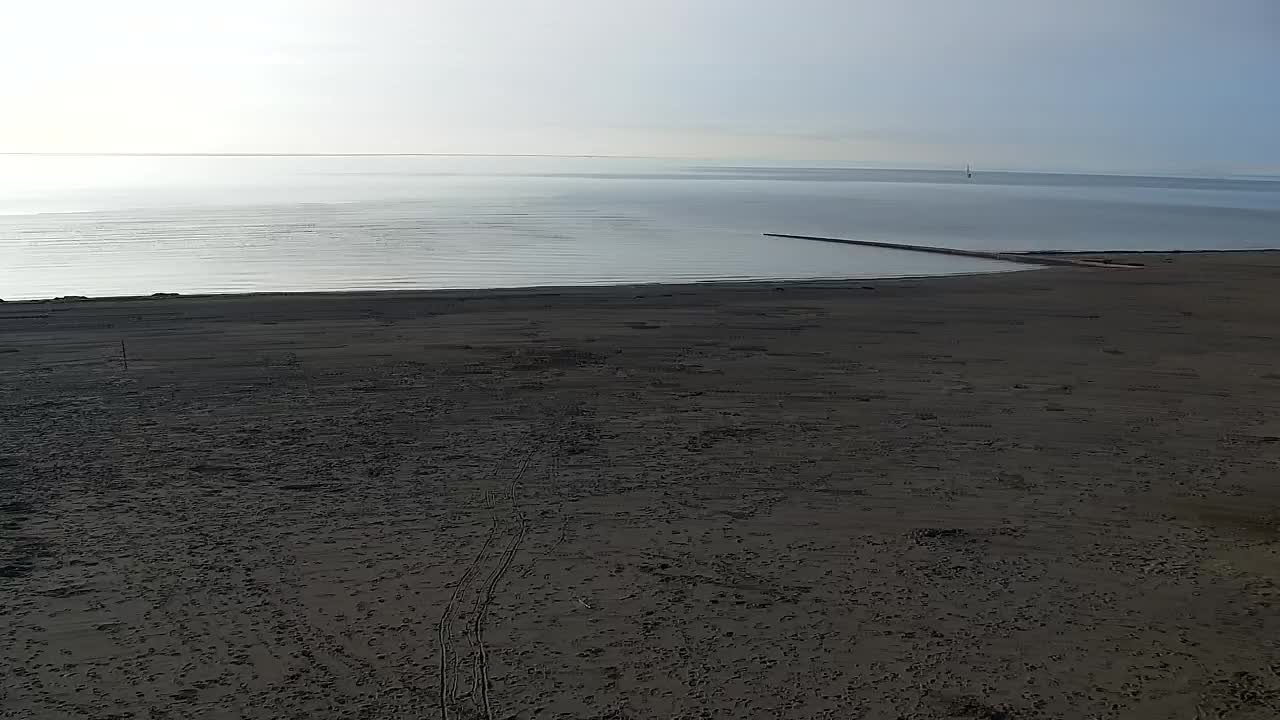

[0,0,1280,174]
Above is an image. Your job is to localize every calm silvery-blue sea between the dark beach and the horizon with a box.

[0,156,1280,300]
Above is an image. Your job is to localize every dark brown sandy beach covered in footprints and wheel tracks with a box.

[0,252,1280,720]
